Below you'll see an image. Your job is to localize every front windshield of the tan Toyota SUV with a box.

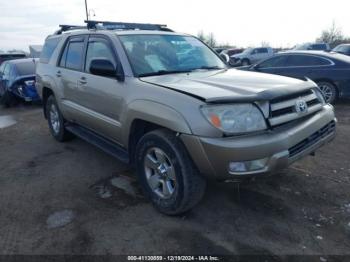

[120,35,226,77]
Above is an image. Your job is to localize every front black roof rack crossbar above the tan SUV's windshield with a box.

[85,20,173,32]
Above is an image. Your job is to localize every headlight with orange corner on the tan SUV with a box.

[201,104,266,134]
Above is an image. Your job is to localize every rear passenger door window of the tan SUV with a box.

[63,41,84,70]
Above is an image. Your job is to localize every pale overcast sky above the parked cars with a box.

[0,0,350,50]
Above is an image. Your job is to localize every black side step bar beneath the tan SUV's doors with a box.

[66,124,129,163]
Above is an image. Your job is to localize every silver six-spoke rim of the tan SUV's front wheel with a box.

[144,147,176,199]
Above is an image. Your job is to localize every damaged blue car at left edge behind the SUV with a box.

[0,58,40,107]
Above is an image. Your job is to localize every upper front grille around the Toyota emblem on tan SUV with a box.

[269,89,322,127]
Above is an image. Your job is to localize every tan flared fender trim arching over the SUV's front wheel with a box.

[121,99,192,145]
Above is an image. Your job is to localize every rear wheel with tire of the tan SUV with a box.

[45,95,74,142]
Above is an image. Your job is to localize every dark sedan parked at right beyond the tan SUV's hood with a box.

[239,51,350,103]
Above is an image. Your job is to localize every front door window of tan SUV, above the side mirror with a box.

[85,39,116,72]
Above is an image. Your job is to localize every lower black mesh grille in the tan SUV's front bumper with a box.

[288,121,335,157]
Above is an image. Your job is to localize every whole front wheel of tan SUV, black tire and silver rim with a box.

[136,129,206,215]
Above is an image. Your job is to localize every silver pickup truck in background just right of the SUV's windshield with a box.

[230,47,274,66]
